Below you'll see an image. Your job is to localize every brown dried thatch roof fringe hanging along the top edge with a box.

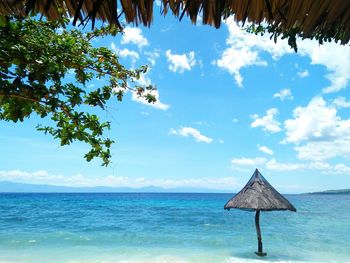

[0,0,350,44]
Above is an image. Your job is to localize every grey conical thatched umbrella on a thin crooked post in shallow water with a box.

[224,169,296,256]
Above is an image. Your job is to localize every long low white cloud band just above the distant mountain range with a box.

[0,170,239,190]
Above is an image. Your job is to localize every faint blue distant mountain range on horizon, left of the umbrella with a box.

[0,181,227,193]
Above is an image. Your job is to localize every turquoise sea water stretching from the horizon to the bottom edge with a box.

[0,193,350,263]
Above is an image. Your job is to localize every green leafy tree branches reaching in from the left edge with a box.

[0,16,156,166]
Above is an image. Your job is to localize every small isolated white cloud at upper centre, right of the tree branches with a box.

[165,49,196,73]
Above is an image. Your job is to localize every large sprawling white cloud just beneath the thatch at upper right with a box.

[214,16,350,93]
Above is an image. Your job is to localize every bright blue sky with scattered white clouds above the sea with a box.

[0,11,350,193]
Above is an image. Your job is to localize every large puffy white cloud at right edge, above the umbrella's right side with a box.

[282,97,350,161]
